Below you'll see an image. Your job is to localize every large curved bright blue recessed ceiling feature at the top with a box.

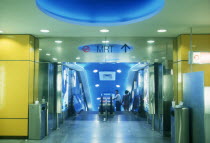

[36,0,165,26]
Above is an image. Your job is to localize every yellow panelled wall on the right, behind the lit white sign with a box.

[173,35,210,102]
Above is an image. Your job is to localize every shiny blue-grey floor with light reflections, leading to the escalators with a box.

[0,112,170,143]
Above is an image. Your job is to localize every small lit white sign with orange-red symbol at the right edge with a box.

[189,52,210,64]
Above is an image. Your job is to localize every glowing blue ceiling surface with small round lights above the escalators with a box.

[77,63,137,111]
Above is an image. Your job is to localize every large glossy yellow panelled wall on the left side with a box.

[0,35,39,136]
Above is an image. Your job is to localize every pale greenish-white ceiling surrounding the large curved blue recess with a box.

[0,0,210,37]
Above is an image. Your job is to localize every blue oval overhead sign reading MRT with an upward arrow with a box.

[78,44,133,53]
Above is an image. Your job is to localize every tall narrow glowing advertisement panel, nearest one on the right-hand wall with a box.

[144,67,149,112]
